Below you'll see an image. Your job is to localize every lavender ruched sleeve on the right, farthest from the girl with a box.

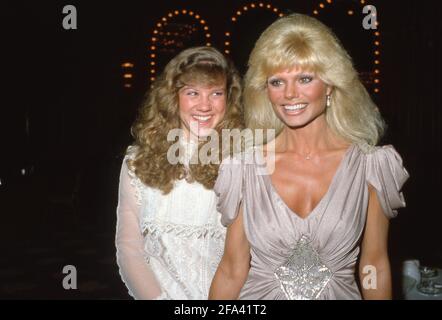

[366,145,409,218]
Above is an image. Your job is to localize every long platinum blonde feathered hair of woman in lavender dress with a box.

[243,14,385,150]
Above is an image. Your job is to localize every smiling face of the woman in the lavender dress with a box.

[267,68,331,128]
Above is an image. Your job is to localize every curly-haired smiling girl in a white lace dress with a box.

[116,47,242,299]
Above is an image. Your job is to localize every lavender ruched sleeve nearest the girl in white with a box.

[214,157,244,227]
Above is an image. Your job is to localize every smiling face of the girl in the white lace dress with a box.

[178,81,227,137]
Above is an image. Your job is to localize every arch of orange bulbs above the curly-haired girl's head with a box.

[149,9,212,82]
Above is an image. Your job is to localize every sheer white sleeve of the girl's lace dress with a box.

[115,157,167,299]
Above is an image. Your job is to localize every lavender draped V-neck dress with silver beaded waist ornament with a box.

[215,145,408,300]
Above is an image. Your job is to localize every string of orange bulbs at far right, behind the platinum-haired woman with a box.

[313,0,381,93]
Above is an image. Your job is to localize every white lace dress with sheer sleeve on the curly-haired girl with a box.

[115,145,226,300]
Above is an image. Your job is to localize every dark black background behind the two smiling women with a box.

[0,0,442,299]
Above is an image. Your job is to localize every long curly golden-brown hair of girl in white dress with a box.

[127,47,243,194]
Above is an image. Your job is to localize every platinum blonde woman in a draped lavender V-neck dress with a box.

[210,14,408,300]
